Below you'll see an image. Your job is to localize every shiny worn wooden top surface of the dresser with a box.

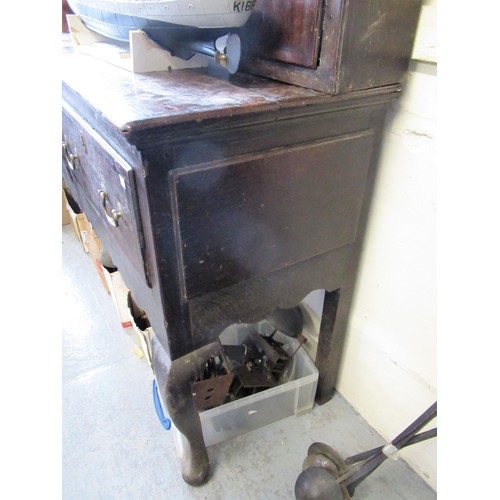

[62,41,331,133]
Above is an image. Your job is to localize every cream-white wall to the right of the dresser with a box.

[338,0,437,489]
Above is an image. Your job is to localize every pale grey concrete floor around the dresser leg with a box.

[62,225,436,500]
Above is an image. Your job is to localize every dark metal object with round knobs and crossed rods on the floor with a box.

[295,402,437,500]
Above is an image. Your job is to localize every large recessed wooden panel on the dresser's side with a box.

[170,131,373,299]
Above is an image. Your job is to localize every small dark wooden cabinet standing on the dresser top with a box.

[242,0,422,94]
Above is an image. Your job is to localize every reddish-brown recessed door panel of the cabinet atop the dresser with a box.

[245,0,322,68]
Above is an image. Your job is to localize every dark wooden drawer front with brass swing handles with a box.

[62,108,150,285]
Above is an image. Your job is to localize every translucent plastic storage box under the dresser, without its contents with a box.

[172,323,318,454]
